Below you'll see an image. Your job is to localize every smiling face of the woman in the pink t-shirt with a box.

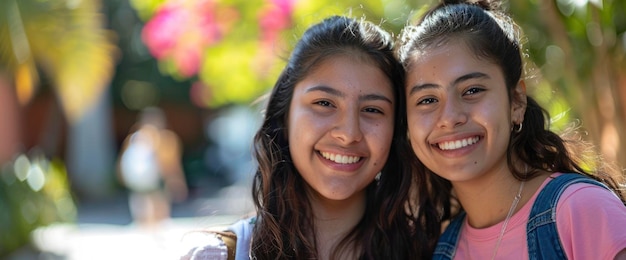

[406,42,524,183]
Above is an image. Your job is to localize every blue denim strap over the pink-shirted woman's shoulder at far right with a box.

[526,173,608,260]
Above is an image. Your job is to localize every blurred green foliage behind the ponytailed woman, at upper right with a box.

[508,0,626,165]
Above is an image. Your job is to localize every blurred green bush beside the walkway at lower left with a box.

[0,155,76,257]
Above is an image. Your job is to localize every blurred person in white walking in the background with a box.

[118,107,188,228]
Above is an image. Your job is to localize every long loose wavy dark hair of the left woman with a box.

[251,16,430,259]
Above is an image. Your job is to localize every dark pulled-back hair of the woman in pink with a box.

[398,0,626,219]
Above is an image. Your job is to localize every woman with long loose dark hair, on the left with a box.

[180,16,439,259]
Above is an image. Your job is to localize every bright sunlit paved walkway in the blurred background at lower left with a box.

[4,182,253,260]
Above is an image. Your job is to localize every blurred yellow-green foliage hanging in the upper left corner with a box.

[0,0,116,121]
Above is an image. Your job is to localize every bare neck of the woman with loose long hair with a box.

[311,190,366,259]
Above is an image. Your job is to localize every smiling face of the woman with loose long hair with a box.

[288,55,395,201]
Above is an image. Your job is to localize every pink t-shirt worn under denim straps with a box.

[454,174,626,259]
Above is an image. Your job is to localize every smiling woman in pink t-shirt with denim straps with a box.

[398,1,626,259]
